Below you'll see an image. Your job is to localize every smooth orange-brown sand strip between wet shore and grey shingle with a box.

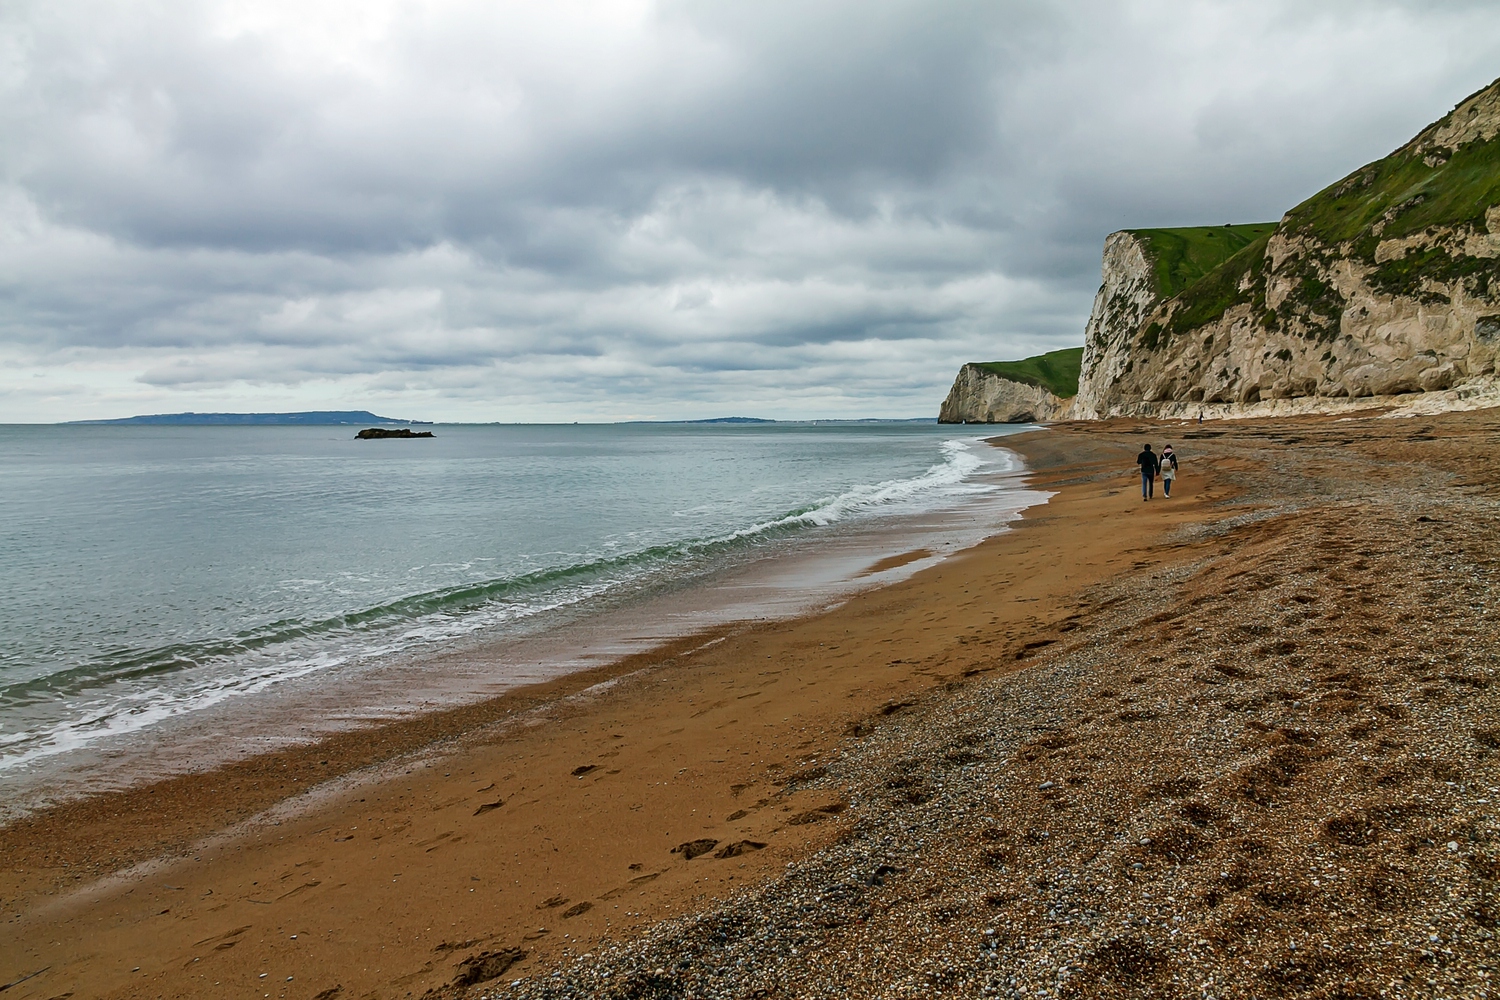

[0,415,1497,1000]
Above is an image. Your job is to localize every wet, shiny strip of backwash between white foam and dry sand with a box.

[0,438,1046,829]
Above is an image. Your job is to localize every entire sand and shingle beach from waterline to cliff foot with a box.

[0,411,1500,1000]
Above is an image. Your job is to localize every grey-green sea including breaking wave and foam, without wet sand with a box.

[0,423,1038,803]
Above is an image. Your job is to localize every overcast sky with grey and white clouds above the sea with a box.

[0,0,1500,421]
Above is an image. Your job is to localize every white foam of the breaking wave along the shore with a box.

[0,422,1019,772]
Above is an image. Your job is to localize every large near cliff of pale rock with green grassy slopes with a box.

[1074,81,1500,418]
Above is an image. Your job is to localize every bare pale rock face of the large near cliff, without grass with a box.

[1079,213,1500,417]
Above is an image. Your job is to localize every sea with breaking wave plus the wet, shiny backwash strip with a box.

[0,423,1047,820]
